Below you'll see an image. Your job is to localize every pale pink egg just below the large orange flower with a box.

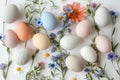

[76,19,93,39]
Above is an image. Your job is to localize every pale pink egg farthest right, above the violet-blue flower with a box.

[95,35,112,53]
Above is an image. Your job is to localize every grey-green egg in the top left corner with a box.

[4,4,20,23]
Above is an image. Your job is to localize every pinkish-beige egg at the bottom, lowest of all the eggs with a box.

[65,55,84,72]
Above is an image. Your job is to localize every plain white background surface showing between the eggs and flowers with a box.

[0,0,120,80]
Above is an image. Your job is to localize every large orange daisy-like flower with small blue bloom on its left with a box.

[63,2,86,23]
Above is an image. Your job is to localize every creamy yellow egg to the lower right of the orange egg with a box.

[32,33,50,50]
